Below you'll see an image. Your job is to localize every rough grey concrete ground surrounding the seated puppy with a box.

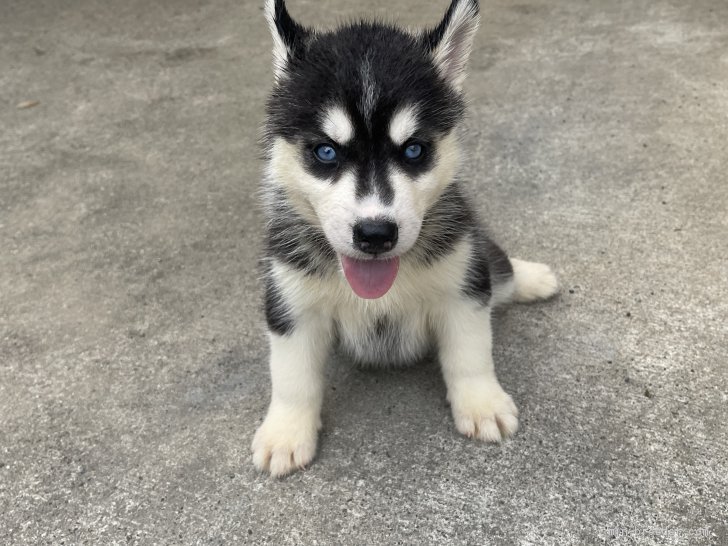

[0,0,728,545]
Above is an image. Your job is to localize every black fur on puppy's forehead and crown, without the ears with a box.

[268,23,463,148]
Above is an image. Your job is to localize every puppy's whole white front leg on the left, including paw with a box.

[252,314,331,477]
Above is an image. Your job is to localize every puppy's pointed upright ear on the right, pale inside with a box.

[425,0,480,91]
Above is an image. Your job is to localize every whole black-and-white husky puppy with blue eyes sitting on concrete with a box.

[252,0,557,476]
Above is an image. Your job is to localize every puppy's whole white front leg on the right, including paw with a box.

[438,298,518,442]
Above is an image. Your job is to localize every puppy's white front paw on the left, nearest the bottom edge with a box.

[252,407,321,478]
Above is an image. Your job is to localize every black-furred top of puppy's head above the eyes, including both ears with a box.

[266,0,478,142]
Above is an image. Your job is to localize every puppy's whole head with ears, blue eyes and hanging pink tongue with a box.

[266,0,479,297]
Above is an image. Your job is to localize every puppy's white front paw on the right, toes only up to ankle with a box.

[448,379,518,442]
